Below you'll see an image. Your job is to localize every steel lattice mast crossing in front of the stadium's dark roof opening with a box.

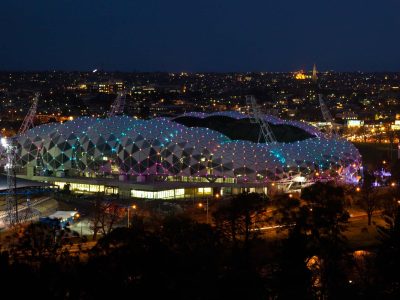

[246,95,276,143]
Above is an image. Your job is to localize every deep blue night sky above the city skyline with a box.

[0,0,400,72]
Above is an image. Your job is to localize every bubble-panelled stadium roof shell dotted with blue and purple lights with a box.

[17,112,361,181]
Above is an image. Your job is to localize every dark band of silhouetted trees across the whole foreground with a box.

[0,184,400,299]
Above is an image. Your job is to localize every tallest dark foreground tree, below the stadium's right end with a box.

[277,183,349,298]
